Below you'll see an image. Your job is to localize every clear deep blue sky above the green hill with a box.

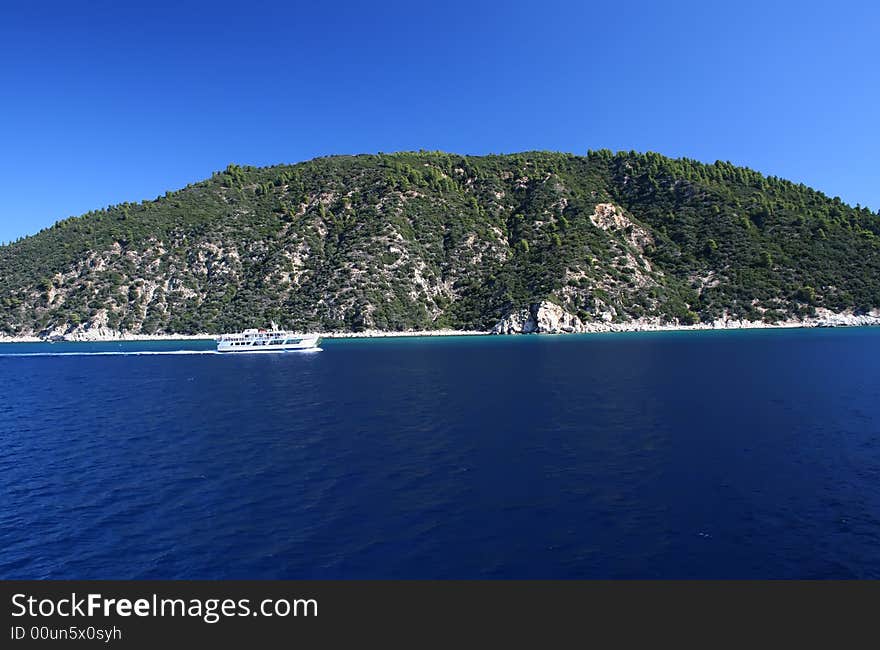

[0,0,880,241]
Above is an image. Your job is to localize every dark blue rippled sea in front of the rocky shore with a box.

[0,329,880,579]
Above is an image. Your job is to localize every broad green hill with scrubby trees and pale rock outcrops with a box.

[0,150,880,335]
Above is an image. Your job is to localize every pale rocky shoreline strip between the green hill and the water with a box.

[0,315,880,343]
